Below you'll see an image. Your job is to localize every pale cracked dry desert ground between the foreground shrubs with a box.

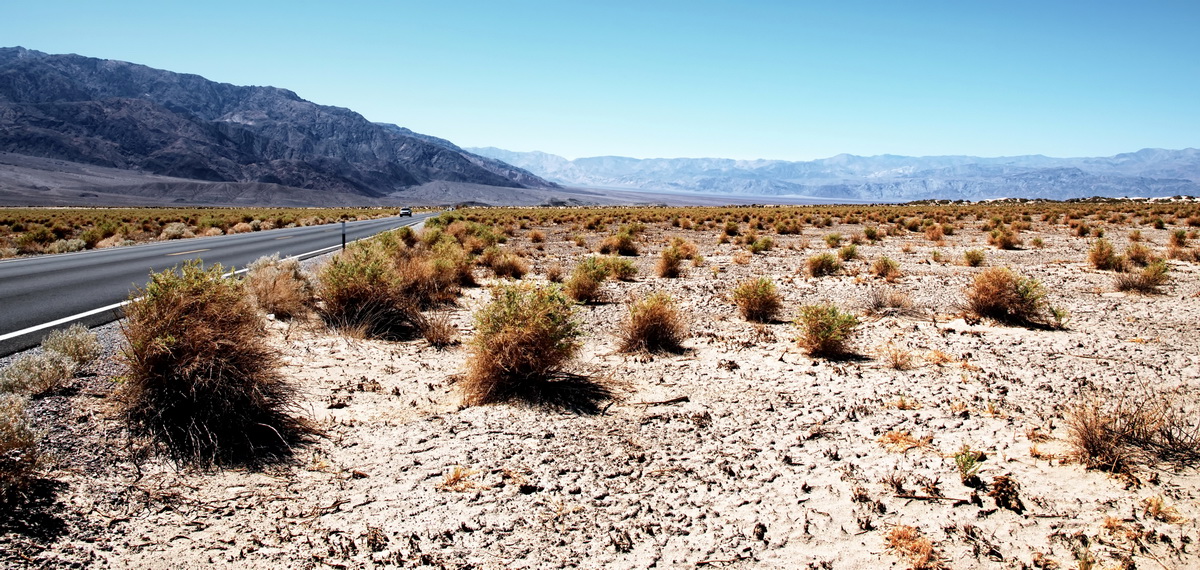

[7,216,1200,569]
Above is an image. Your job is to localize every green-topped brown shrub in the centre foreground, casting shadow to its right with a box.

[462,283,583,406]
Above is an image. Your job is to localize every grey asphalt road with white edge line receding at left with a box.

[0,214,436,356]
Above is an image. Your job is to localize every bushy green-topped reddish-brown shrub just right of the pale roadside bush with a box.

[317,242,432,338]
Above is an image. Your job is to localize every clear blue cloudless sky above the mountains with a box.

[0,0,1200,160]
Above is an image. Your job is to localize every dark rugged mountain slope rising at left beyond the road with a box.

[0,48,557,203]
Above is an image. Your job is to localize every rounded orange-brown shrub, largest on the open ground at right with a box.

[966,268,1045,324]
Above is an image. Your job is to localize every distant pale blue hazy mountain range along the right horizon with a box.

[467,148,1200,202]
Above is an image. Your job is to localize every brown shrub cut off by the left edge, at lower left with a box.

[0,394,41,505]
